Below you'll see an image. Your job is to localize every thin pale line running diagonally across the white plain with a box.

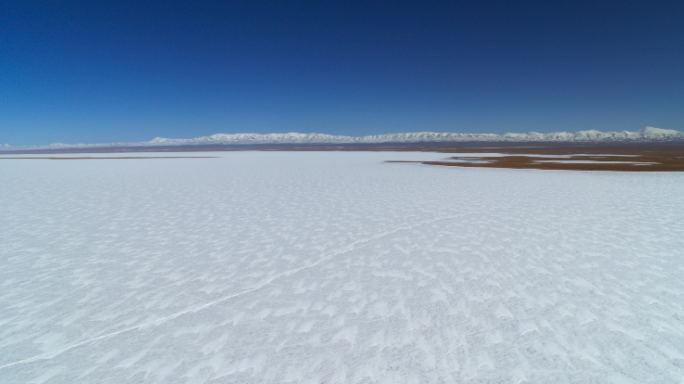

[0,216,458,369]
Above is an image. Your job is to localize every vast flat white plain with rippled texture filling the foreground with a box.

[0,152,684,384]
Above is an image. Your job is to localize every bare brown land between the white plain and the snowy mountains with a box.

[0,141,684,172]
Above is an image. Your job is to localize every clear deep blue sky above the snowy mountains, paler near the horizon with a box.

[0,0,684,145]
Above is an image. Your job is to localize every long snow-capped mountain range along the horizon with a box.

[0,127,684,151]
